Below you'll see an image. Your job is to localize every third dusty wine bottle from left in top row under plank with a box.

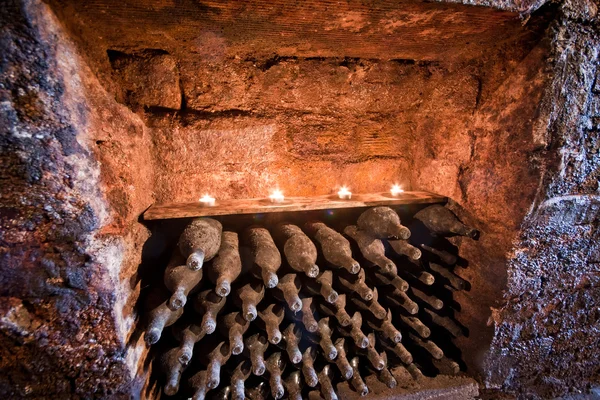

[245,226,281,289]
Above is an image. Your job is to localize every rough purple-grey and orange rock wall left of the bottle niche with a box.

[0,0,151,398]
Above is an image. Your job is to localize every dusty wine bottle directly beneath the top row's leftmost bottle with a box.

[164,249,202,310]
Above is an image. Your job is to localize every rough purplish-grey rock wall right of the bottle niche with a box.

[486,2,600,398]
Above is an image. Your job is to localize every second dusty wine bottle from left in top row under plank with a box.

[207,232,242,297]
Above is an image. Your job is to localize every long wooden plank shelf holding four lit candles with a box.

[144,192,448,220]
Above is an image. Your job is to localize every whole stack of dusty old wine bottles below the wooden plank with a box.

[145,205,479,400]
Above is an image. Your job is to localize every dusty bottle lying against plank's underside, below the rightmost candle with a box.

[356,207,410,240]
